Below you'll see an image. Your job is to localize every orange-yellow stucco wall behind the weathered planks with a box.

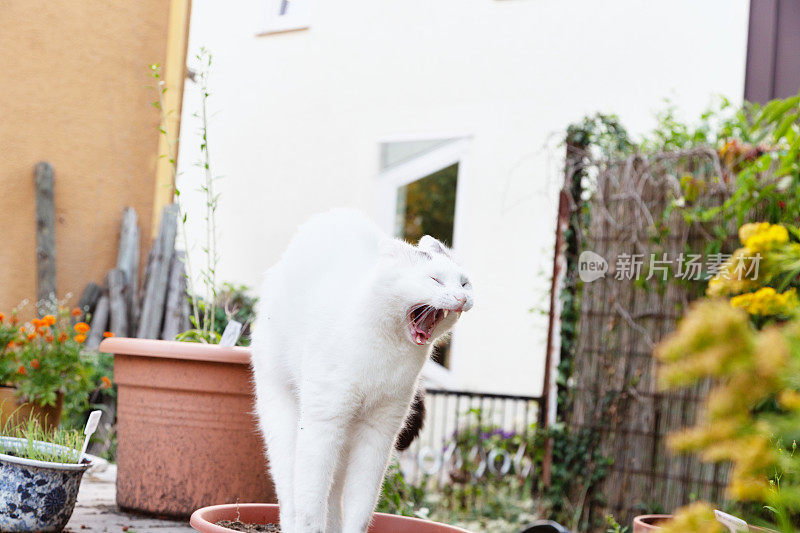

[0,0,185,315]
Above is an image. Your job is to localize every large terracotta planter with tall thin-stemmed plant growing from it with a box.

[100,52,275,517]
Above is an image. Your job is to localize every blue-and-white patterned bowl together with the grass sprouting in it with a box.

[0,417,91,532]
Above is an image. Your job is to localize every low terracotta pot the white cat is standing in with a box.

[189,503,476,533]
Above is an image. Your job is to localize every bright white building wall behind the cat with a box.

[179,0,748,394]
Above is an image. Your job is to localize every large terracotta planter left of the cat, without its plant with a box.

[100,337,276,517]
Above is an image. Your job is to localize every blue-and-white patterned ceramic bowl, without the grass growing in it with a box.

[0,437,91,532]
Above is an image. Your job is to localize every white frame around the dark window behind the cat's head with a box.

[376,135,472,389]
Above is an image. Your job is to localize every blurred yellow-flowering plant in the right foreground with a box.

[634,223,800,533]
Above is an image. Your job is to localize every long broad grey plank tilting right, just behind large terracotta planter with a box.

[136,204,178,339]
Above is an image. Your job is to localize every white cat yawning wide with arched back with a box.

[252,209,472,533]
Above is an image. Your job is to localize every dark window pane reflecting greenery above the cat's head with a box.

[395,164,458,246]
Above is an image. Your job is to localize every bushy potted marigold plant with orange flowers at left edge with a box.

[0,306,91,431]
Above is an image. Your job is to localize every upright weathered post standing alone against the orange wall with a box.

[34,161,58,312]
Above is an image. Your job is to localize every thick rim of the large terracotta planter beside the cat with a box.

[98,337,250,365]
